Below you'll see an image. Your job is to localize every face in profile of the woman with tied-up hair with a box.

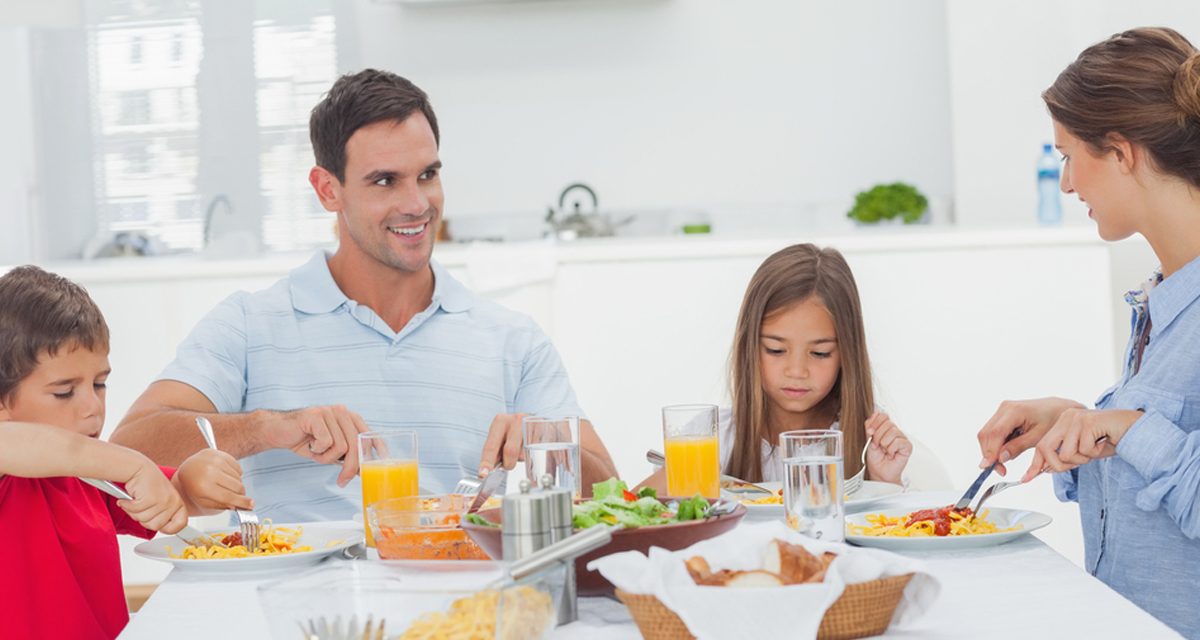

[1054,122,1138,240]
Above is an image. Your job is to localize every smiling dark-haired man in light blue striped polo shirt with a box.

[112,70,616,521]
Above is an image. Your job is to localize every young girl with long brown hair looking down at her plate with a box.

[642,244,912,491]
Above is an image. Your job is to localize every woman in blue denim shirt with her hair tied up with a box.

[979,29,1200,638]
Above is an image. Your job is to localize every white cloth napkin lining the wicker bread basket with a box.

[588,521,941,640]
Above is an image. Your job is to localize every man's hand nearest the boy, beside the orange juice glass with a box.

[264,405,369,486]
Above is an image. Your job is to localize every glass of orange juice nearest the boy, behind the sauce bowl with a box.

[359,429,416,546]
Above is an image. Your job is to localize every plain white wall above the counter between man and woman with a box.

[354,0,952,226]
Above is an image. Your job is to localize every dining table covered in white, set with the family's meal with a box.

[120,496,1182,640]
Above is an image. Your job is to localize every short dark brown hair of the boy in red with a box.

[0,265,108,401]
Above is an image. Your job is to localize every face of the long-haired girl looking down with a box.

[758,297,841,429]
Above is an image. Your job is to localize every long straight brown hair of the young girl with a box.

[726,244,875,482]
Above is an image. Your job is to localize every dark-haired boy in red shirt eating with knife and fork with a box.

[0,267,252,639]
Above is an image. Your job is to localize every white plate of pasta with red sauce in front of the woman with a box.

[846,506,1051,550]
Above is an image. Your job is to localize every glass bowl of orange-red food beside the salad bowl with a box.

[367,494,488,561]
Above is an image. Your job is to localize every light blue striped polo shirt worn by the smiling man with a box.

[158,252,582,522]
